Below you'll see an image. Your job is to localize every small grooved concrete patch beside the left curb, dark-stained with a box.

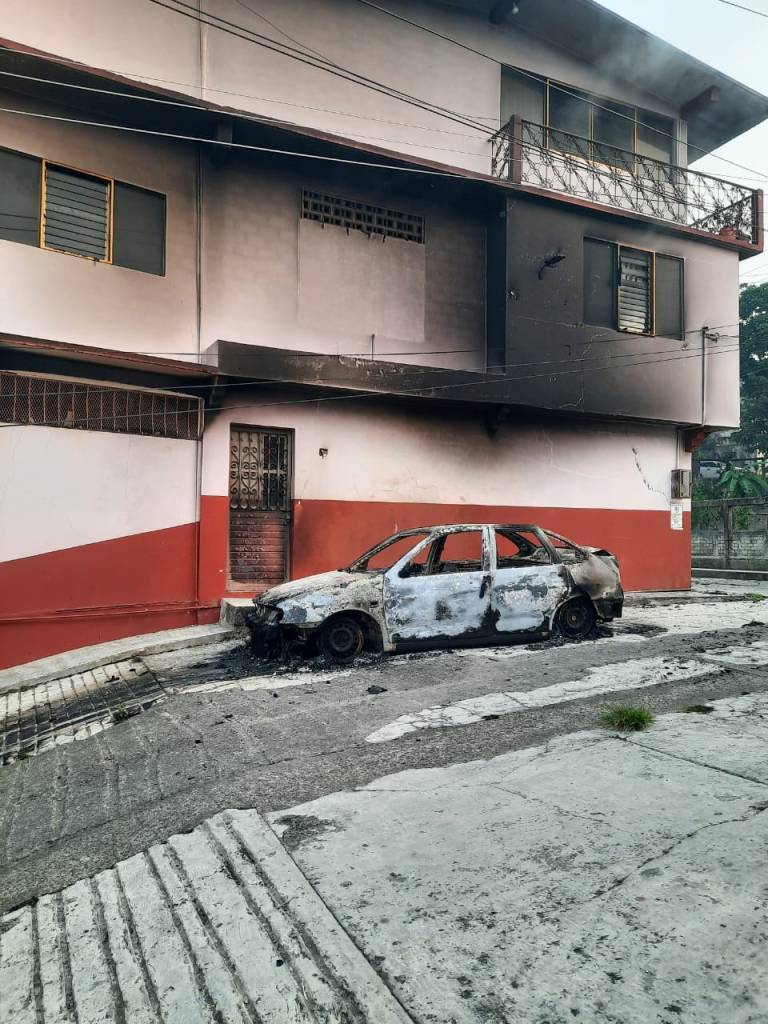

[0,660,169,765]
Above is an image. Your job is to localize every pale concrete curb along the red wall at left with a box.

[0,623,236,693]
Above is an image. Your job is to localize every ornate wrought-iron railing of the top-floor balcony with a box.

[492,118,762,246]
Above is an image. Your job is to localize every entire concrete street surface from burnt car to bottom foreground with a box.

[0,581,768,1024]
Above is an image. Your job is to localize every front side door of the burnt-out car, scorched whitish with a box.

[384,527,493,646]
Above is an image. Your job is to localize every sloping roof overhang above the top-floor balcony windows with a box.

[442,0,768,154]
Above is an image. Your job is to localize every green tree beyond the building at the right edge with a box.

[698,282,768,464]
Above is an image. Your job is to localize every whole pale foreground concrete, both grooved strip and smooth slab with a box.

[0,694,768,1024]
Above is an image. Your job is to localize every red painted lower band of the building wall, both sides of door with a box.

[0,496,690,668]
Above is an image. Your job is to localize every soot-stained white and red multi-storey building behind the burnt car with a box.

[0,0,768,665]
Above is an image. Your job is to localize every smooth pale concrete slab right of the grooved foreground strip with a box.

[268,694,768,1024]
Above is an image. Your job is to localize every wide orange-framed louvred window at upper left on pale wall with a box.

[0,150,166,275]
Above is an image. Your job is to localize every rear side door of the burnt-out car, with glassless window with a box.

[492,526,570,633]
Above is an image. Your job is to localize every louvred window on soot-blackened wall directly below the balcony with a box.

[584,239,685,339]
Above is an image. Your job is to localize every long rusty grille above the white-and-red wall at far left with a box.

[0,371,201,440]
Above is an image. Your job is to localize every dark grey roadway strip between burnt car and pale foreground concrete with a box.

[0,602,768,910]
